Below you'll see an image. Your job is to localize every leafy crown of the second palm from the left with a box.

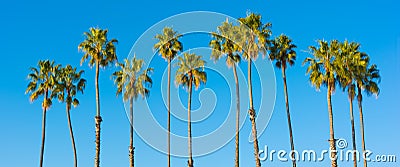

[55,65,86,109]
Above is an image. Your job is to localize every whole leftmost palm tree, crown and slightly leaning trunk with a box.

[25,60,59,167]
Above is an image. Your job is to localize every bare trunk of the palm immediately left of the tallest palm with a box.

[233,64,240,167]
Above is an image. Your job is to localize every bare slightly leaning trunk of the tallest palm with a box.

[247,58,261,167]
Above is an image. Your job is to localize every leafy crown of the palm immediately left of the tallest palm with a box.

[209,21,240,67]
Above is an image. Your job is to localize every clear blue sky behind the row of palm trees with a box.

[0,0,400,167]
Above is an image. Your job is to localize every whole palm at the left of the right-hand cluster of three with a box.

[303,40,341,167]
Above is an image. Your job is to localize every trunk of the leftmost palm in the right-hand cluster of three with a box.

[327,83,337,167]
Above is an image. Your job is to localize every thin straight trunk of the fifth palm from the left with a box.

[167,59,171,167]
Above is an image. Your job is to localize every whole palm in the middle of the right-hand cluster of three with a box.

[337,40,369,167]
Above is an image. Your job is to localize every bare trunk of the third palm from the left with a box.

[94,62,102,167]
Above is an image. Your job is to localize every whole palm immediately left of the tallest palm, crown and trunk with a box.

[210,20,240,167]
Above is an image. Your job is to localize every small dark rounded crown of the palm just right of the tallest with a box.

[269,34,296,69]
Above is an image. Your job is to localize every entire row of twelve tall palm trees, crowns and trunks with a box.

[26,13,380,167]
